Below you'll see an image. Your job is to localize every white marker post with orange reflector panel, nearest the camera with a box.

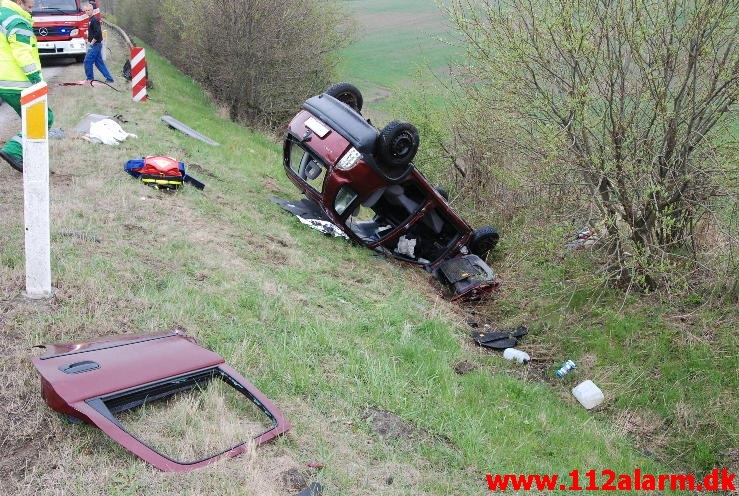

[21,81,51,298]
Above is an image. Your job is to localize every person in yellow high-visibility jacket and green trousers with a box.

[0,0,54,172]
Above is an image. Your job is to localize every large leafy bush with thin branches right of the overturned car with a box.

[449,0,739,289]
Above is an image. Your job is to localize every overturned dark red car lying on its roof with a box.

[283,83,499,300]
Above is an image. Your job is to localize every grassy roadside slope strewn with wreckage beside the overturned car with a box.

[0,11,736,495]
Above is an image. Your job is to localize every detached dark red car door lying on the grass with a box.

[31,330,291,472]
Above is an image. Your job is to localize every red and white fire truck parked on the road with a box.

[31,0,100,62]
